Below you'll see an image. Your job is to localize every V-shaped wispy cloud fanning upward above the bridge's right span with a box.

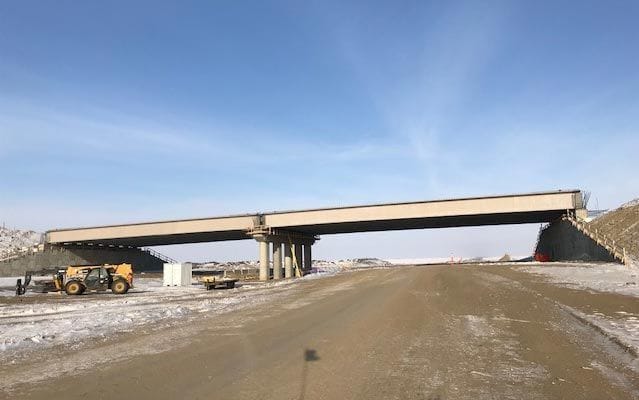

[316,4,509,197]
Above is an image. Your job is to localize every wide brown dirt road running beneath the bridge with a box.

[5,266,639,399]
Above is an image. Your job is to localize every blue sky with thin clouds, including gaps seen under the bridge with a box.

[0,1,639,259]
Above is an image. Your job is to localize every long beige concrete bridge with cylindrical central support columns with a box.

[45,190,585,280]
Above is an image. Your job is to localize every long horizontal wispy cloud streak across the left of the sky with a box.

[0,99,406,164]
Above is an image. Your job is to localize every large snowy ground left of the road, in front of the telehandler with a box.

[0,278,308,362]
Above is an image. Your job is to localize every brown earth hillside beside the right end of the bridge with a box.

[589,199,639,260]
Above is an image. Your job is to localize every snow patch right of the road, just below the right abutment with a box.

[521,263,639,297]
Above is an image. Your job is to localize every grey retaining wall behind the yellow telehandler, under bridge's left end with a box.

[0,247,164,276]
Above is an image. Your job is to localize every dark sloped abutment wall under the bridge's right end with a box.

[536,220,615,262]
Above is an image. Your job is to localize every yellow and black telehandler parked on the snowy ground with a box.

[16,264,133,295]
